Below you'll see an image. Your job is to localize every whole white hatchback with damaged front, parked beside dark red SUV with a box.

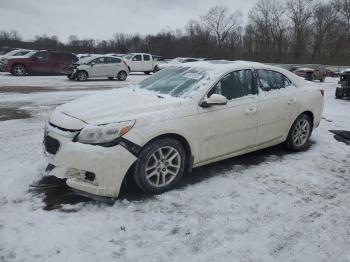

[67,55,129,81]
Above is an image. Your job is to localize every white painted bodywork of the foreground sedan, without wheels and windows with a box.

[44,61,323,197]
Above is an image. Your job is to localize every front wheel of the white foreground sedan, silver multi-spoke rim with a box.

[134,138,186,194]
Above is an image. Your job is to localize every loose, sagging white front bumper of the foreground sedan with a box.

[44,125,137,198]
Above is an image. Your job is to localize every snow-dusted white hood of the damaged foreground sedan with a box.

[50,88,184,128]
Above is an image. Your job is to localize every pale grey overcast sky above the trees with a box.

[0,0,256,41]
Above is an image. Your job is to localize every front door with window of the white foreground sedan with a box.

[198,70,258,162]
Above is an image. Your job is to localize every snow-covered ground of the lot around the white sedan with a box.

[0,75,350,262]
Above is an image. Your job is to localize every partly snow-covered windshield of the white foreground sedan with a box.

[139,66,207,97]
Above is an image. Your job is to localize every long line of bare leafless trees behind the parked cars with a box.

[0,0,350,65]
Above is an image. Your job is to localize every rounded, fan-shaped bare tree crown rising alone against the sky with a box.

[201,5,242,51]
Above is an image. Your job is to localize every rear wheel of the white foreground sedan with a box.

[285,114,313,151]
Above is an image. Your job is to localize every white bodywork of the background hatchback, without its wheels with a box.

[72,55,128,78]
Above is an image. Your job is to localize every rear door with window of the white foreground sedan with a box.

[256,70,297,145]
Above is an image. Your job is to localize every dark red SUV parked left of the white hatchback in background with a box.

[4,51,78,76]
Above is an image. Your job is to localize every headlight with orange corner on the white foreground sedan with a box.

[76,120,135,145]
